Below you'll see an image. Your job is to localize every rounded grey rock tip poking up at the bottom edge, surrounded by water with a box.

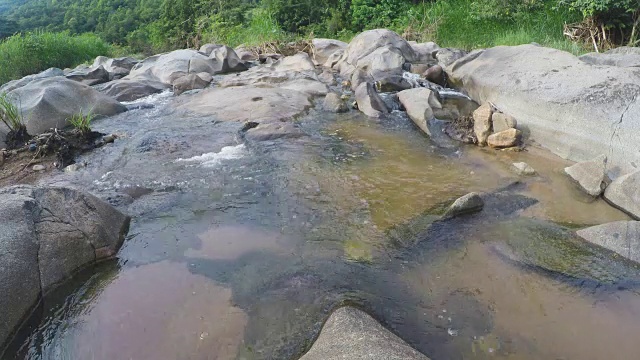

[300,307,429,360]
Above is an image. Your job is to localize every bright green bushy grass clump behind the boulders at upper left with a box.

[0,32,110,84]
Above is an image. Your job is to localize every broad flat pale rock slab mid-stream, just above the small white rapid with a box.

[177,86,313,123]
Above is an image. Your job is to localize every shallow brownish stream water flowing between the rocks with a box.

[2,90,640,360]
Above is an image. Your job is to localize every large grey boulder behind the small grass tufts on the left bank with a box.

[9,77,127,135]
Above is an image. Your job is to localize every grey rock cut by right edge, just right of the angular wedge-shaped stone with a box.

[604,170,640,219]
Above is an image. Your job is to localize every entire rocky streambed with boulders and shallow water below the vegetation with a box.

[0,30,640,360]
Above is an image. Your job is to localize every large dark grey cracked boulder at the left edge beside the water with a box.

[0,186,130,349]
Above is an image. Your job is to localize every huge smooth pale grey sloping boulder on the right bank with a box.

[446,45,640,176]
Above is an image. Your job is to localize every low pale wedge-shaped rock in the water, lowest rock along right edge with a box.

[576,221,640,262]
